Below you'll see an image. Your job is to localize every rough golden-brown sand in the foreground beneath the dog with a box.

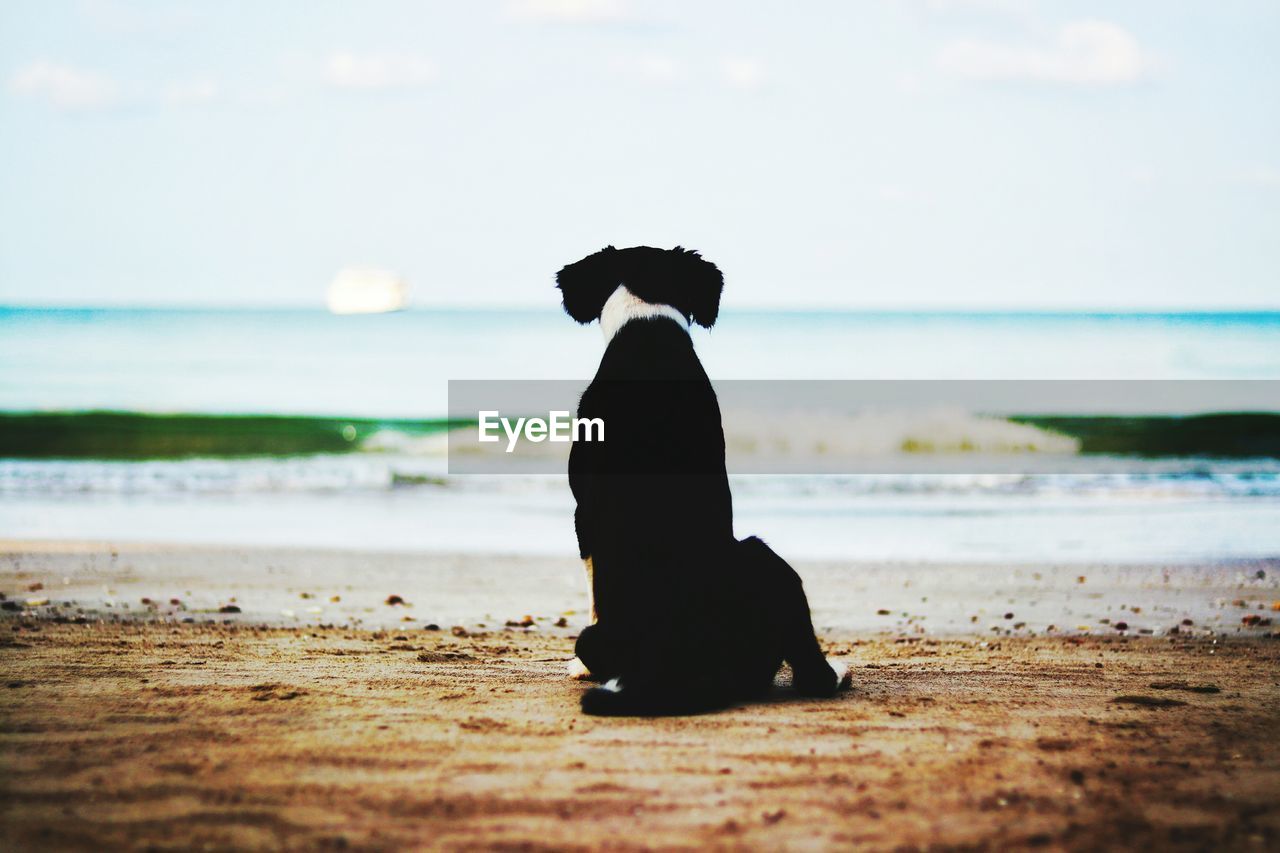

[0,547,1280,849]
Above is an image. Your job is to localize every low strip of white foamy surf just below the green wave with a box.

[0,453,1280,499]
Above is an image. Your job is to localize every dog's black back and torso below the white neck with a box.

[570,312,733,680]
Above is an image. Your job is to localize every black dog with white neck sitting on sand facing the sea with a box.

[556,246,850,716]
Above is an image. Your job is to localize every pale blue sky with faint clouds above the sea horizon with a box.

[0,0,1280,310]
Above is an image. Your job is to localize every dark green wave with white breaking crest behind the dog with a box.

[0,409,1280,470]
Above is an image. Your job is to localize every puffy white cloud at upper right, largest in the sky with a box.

[937,20,1152,86]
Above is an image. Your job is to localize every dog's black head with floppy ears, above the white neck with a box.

[556,246,724,329]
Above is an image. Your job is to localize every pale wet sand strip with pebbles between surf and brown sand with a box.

[0,539,1280,637]
